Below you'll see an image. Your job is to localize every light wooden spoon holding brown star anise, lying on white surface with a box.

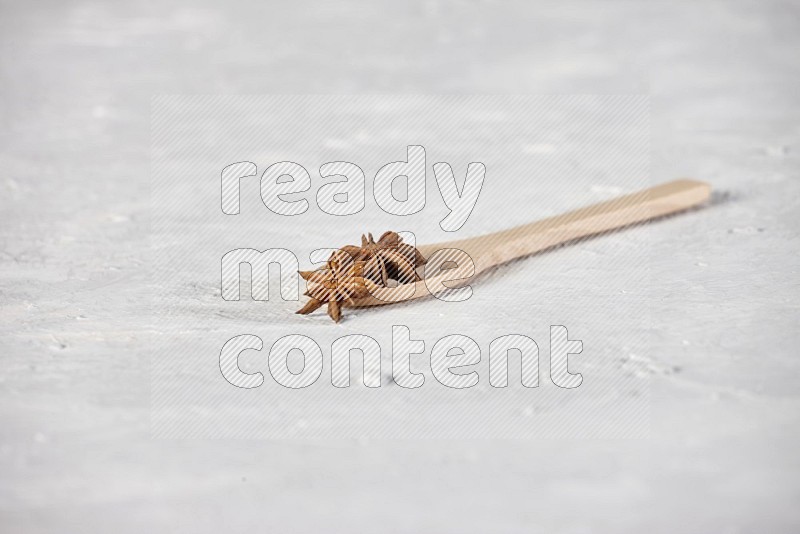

[342,180,711,307]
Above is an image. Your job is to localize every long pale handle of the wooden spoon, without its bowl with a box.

[421,180,711,274]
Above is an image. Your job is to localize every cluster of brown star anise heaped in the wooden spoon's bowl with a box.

[297,232,426,322]
